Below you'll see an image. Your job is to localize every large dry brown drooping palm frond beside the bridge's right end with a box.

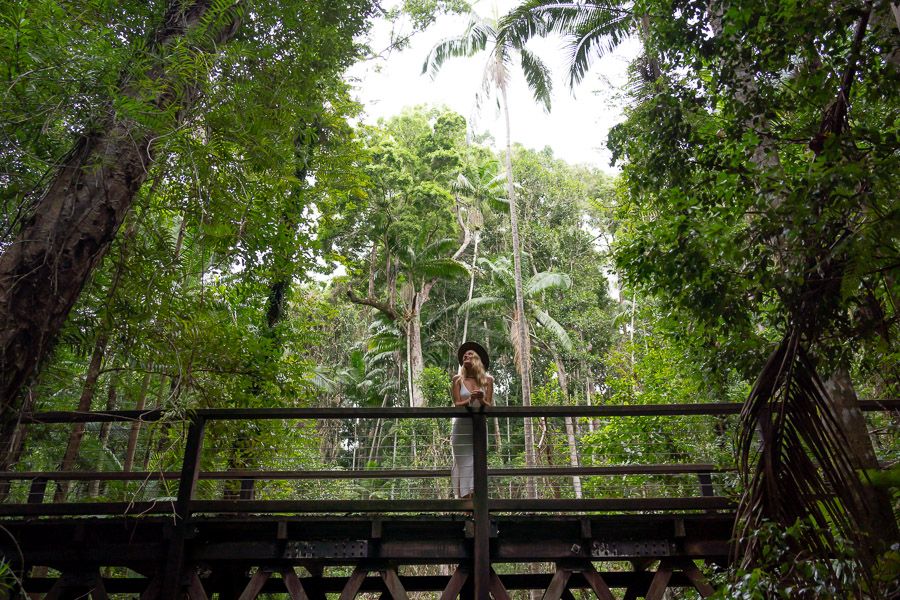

[736,330,871,580]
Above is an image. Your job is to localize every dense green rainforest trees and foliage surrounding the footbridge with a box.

[0,0,900,598]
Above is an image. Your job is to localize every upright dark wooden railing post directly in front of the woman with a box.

[472,410,491,600]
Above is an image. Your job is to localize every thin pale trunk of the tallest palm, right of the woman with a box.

[500,84,537,498]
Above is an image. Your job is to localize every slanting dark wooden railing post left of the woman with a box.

[160,414,206,599]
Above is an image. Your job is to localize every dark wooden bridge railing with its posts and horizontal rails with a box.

[0,400,900,597]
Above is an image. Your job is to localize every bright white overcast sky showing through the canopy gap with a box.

[349,0,639,170]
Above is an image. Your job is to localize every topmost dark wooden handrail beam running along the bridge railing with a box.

[22,399,900,424]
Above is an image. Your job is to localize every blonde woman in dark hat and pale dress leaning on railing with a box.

[450,342,494,498]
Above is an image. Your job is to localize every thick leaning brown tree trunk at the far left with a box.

[0,0,243,450]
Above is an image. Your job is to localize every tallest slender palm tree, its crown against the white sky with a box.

[422,13,551,497]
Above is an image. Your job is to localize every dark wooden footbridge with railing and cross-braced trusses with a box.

[0,401,900,600]
